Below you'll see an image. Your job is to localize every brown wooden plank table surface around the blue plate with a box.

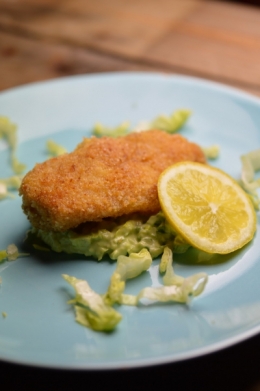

[0,0,260,391]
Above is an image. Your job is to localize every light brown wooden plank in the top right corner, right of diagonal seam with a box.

[144,1,260,86]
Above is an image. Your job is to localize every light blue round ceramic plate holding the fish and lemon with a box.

[0,73,260,369]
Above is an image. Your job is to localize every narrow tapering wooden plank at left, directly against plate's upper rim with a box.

[0,32,160,90]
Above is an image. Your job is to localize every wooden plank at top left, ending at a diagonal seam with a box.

[0,0,202,58]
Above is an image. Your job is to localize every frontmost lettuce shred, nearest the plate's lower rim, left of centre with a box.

[63,274,122,331]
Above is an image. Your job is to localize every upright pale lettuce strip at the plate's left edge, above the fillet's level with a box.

[0,117,26,175]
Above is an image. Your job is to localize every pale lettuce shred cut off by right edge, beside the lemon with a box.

[239,149,260,210]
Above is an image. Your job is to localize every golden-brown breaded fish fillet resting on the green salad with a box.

[20,130,205,231]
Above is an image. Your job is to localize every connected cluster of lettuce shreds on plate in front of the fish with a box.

[63,247,208,331]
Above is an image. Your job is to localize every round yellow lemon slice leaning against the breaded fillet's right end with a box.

[158,162,256,254]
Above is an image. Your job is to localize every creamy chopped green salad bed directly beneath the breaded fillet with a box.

[31,212,190,260]
